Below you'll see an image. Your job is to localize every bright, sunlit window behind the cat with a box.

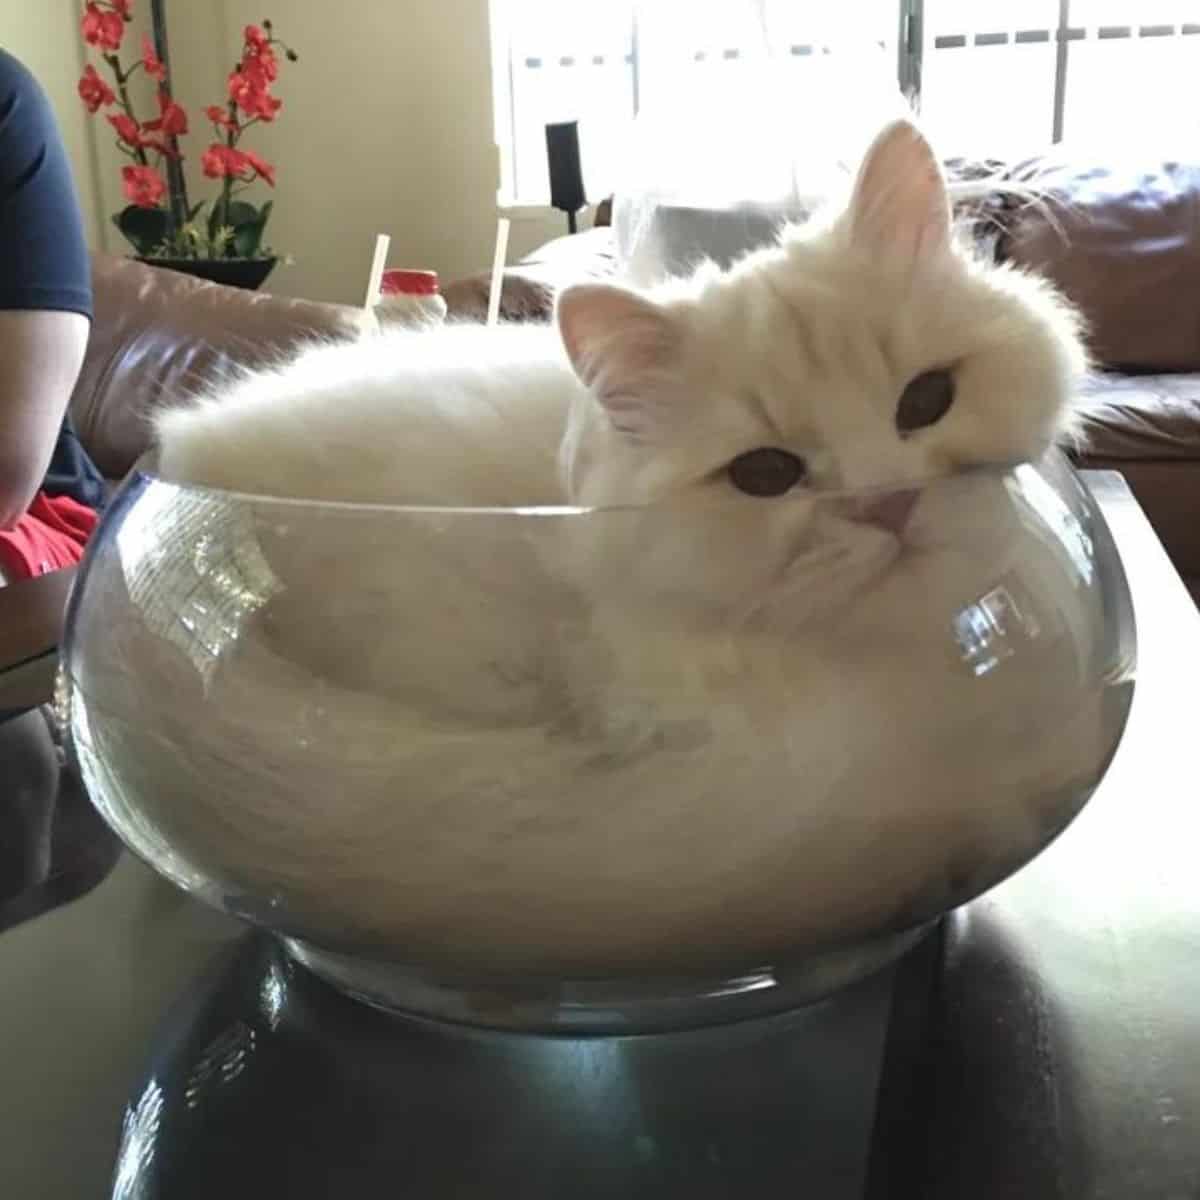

[492,0,1200,204]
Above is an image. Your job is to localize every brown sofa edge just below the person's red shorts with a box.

[0,566,77,714]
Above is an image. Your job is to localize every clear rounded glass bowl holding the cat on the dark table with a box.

[61,456,1134,1028]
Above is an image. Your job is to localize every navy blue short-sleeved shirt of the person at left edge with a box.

[0,50,104,508]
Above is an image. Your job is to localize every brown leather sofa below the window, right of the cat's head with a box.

[997,155,1200,601]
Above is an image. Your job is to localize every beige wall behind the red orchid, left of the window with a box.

[0,0,560,301]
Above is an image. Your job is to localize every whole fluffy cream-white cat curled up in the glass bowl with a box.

[87,121,1111,972]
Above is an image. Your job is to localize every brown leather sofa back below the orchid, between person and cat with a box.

[71,254,377,479]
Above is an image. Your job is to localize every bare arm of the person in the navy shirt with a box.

[0,311,89,529]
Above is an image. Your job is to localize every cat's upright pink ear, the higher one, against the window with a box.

[848,120,950,264]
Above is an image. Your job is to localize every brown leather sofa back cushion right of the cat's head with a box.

[1001,154,1200,371]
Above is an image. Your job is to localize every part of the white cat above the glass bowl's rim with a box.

[158,122,1084,524]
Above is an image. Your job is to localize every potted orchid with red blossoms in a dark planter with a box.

[78,0,296,288]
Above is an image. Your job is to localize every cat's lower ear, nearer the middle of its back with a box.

[557,283,680,437]
